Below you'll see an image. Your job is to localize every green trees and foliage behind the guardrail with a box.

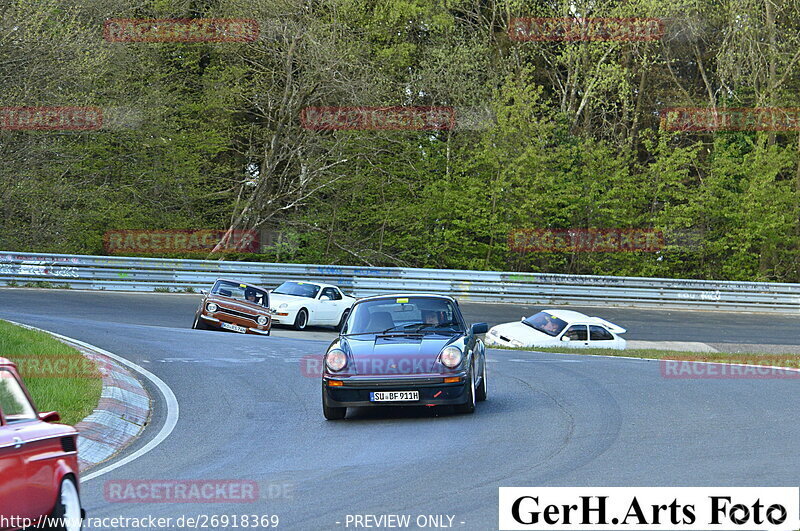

[0,0,800,282]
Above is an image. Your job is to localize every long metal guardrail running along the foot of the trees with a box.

[0,252,800,314]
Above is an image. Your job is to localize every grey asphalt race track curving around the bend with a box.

[0,289,800,530]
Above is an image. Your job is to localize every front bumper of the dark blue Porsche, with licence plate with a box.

[322,372,467,407]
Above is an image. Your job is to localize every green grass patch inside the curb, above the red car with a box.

[0,321,102,424]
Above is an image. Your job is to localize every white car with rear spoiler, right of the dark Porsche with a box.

[486,310,626,350]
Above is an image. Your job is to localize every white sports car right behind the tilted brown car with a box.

[269,280,356,330]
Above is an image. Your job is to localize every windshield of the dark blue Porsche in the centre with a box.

[346,297,464,335]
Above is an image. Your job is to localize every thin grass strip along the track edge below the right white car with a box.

[489,345,800,367]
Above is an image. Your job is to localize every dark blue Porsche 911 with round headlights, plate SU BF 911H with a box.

[322,294,488,420]
